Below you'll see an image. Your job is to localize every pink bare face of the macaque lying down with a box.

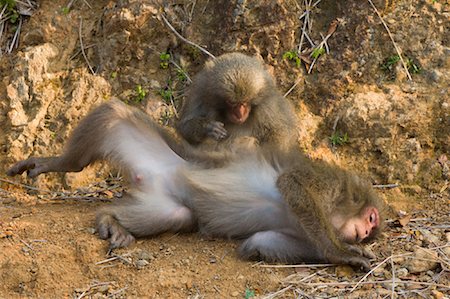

[339,207,380,243]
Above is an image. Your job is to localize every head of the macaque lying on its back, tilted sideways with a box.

[331,173,384,243]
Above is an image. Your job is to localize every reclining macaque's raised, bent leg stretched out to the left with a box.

[7,100,186,177]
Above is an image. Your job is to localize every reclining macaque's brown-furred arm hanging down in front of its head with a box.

[277,170,370,270]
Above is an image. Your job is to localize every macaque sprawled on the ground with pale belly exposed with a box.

[8,100,383,269]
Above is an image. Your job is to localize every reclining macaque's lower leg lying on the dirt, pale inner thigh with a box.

[96,192,196,248]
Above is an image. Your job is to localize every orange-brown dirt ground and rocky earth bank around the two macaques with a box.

[0,0,450,298]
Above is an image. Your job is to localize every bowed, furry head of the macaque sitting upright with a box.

[205,53,274,125]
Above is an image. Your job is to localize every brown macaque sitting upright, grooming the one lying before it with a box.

[177,53,297,148]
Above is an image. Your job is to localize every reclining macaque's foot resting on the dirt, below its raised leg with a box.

[97,213,134,249]
